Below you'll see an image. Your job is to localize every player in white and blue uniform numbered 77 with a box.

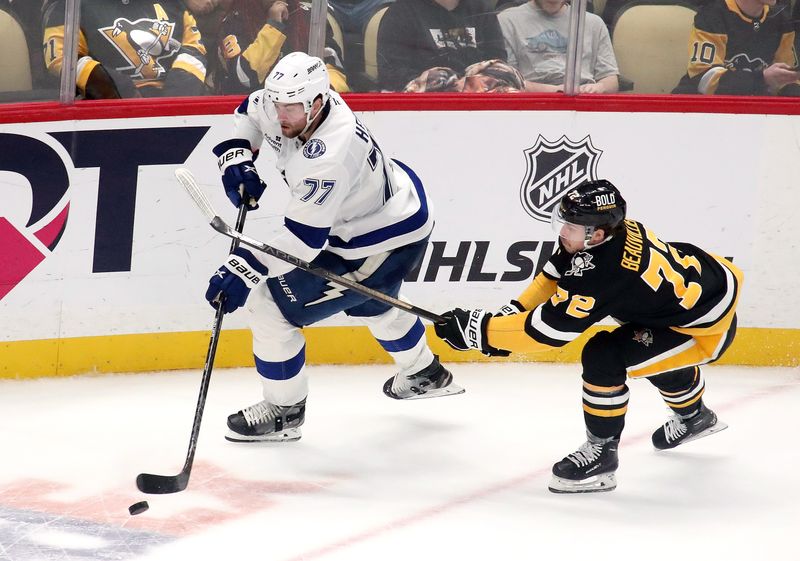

[206,52,464,442]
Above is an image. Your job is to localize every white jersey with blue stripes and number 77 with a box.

[228,90,433,277]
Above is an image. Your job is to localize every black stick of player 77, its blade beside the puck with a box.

[136,169,247,495]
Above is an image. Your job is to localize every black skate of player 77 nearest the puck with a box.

[225,399,306,442]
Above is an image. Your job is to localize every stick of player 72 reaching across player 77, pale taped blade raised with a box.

[175,169,447,323]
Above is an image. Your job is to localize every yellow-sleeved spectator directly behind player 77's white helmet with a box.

[213,0,350,94]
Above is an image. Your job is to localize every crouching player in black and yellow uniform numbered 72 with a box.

[435,180,742,493]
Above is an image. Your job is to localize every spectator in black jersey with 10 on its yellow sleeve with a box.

[673,0,800,95]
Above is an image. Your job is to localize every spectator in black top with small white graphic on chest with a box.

[378,0,506,91]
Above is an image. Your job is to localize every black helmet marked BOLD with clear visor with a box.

[554,179,627,234]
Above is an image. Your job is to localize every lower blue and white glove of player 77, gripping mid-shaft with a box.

[206,247,267,314]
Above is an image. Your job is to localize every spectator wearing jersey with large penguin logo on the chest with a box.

[43,0,206,99]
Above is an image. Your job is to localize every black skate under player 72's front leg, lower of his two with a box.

[549,434,619,493]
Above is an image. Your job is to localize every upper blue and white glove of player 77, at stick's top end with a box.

[214,138,267,209]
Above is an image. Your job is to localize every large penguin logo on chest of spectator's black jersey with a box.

[99,5,181,80]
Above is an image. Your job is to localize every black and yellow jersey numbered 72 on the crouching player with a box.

[488,220,742,351]
